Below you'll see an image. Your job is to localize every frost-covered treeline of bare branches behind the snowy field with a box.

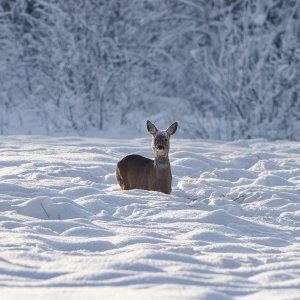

[0,0,300,140]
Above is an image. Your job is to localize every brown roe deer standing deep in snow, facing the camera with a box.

[116,121,177,194]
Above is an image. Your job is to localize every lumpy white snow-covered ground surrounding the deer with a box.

[0,136,300,300]
